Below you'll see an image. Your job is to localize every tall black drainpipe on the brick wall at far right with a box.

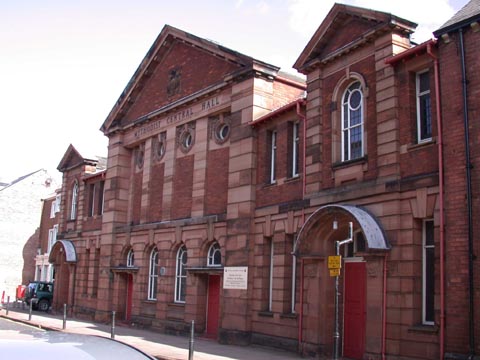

[458,28,475,358]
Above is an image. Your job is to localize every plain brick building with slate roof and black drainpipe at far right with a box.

[434,0,480,356]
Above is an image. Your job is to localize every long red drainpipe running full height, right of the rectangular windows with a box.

[427,44,445,359]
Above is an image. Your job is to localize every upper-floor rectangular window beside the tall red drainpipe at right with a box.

[416,70,432,143]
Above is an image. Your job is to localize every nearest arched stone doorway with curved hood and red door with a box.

[294,205,390,359]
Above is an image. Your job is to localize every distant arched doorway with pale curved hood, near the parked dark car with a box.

[48,240,77,310]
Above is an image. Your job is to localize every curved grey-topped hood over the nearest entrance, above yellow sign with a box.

[293,205,390,255]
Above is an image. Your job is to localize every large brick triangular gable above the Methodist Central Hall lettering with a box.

[101,25,278,133]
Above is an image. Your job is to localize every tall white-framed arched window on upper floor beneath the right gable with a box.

[342,81,364,161]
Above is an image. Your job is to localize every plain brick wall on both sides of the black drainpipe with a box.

[439,28,480,354]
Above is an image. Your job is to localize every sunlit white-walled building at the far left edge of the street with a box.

[0,169,57,302]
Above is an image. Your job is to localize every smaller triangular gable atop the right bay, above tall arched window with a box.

[293,4,417,73]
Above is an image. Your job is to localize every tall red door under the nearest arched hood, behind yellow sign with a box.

[343,262,366,359]
